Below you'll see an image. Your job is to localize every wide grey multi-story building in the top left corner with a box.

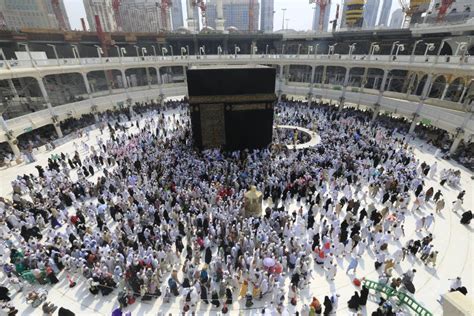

[0,0,71,30]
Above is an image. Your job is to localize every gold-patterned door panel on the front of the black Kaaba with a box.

[200,103,225,149]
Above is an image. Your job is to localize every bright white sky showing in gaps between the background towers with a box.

[63,0,400,31]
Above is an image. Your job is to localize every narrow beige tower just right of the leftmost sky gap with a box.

[84,0,118,32]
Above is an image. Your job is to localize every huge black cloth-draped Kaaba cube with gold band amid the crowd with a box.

[186,66,276,151]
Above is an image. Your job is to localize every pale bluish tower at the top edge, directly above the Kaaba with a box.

[206,0,260,31]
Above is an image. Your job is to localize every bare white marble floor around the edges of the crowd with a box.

[0,110,474,315]
